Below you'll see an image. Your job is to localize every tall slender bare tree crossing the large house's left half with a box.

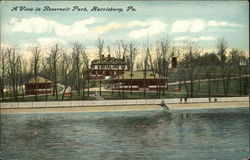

[96,38,104,96]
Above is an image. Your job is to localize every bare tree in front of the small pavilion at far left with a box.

[31,45,41,101]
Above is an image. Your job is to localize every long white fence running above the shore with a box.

[0,97,249,109]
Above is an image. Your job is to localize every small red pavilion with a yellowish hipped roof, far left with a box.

[25,76,52,95]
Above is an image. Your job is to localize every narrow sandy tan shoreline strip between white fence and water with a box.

[1,101,249,114]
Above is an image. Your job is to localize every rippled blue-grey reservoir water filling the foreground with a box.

[1,108,249,160]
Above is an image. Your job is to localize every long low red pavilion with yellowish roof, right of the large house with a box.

[108,71,167,91]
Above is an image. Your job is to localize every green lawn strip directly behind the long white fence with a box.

[1,77,249,102]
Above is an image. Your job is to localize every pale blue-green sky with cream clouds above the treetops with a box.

[1,1,249,57]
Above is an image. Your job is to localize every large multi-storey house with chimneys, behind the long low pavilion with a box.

[85,55,128,79]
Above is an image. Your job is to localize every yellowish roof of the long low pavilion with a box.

[115,71,162,79]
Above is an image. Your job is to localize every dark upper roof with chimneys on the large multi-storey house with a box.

[91,56,127,65]
